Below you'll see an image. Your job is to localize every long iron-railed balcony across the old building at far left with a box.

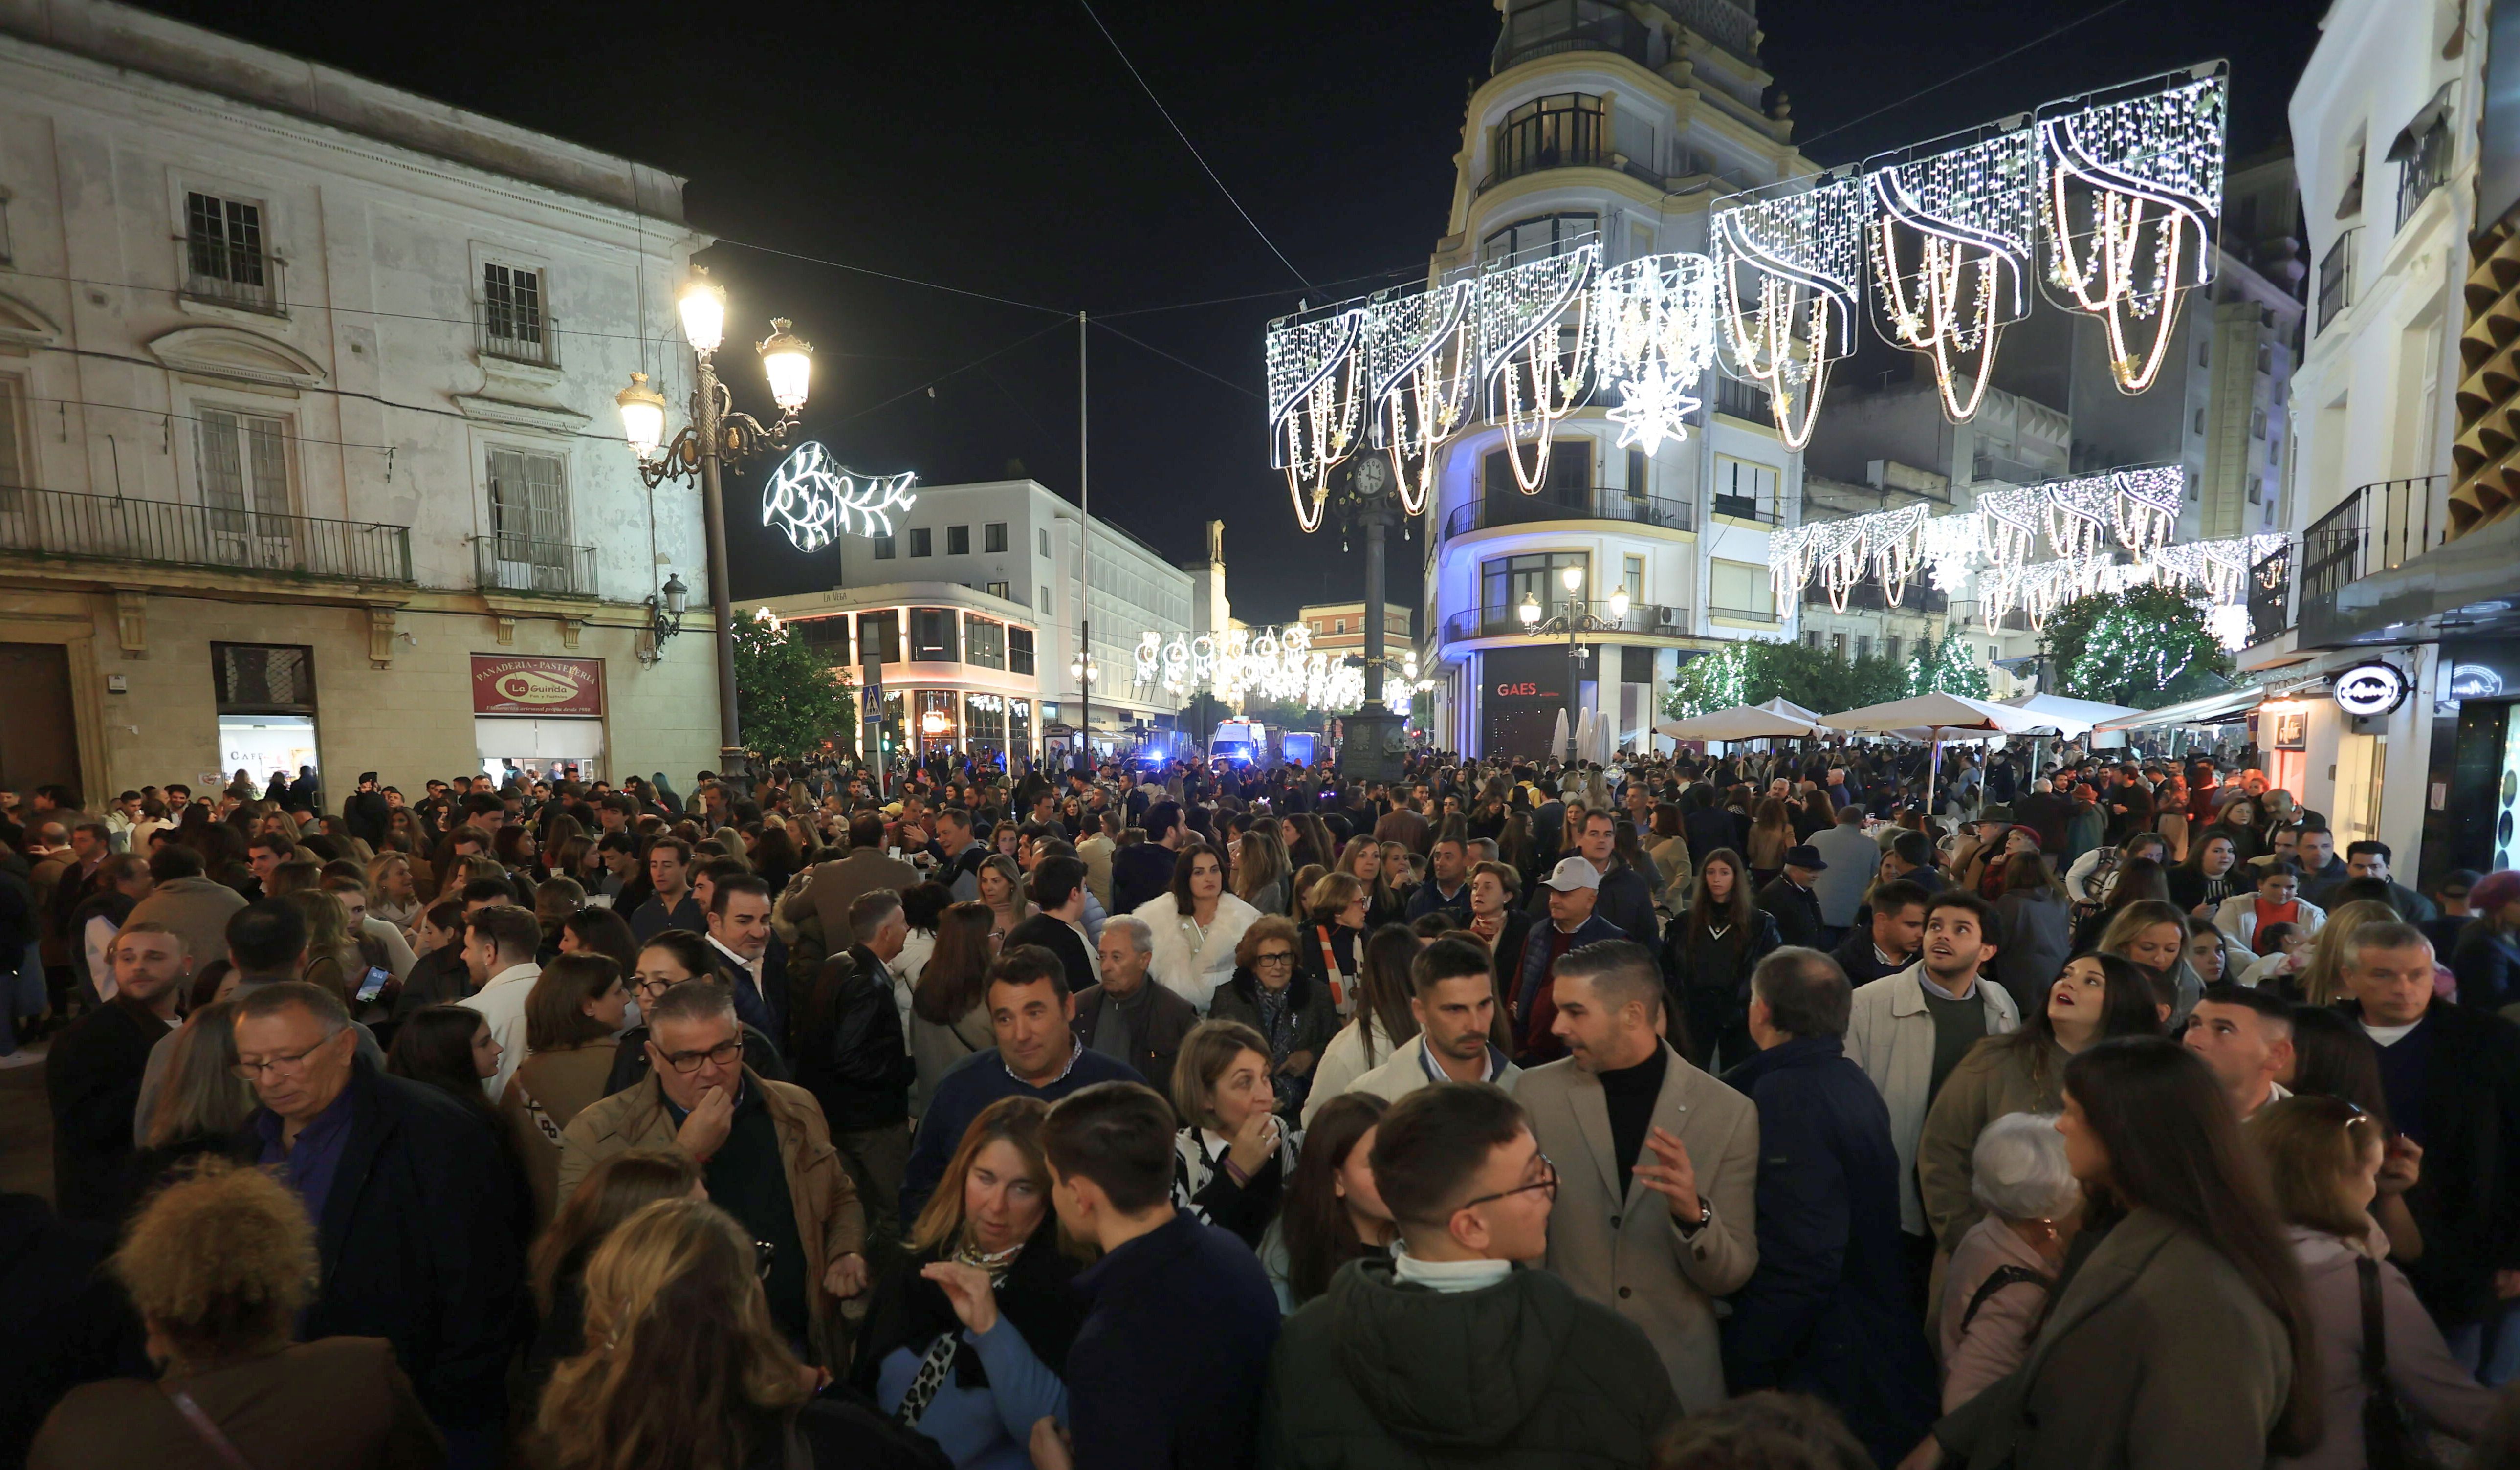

[0,489,413,585]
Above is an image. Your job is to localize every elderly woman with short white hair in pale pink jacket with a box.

[1940,1112,2082,1415]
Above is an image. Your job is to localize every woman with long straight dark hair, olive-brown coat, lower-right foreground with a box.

[1910,1036,2321,1470]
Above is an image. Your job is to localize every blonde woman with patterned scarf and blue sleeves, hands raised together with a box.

[849,1097,1086,1468]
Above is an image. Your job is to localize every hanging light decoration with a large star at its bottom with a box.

[1593,255,1716,454]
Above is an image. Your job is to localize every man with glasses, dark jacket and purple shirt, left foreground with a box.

[229,978,524,1465]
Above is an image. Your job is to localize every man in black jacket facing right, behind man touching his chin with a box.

[796,888,920,1238]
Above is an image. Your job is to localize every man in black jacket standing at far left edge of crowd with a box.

[43,923,192,1226]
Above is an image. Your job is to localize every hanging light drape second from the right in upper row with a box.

[1865,113,2038,424]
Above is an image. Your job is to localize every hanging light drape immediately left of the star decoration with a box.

[1471,237,1600,494]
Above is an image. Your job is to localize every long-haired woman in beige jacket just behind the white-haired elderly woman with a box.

[1915,950,2162,1251]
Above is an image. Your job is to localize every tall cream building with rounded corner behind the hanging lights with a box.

[1421,0,1812,756]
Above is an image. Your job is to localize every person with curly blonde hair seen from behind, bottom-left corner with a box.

[28,1160,446,1470]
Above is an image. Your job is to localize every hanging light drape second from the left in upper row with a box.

[1360,280,1479,514]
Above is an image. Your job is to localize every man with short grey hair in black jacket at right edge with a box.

[2344,923,2520,1369]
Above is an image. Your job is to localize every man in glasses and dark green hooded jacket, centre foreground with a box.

[1260,1074,1681,1468]
